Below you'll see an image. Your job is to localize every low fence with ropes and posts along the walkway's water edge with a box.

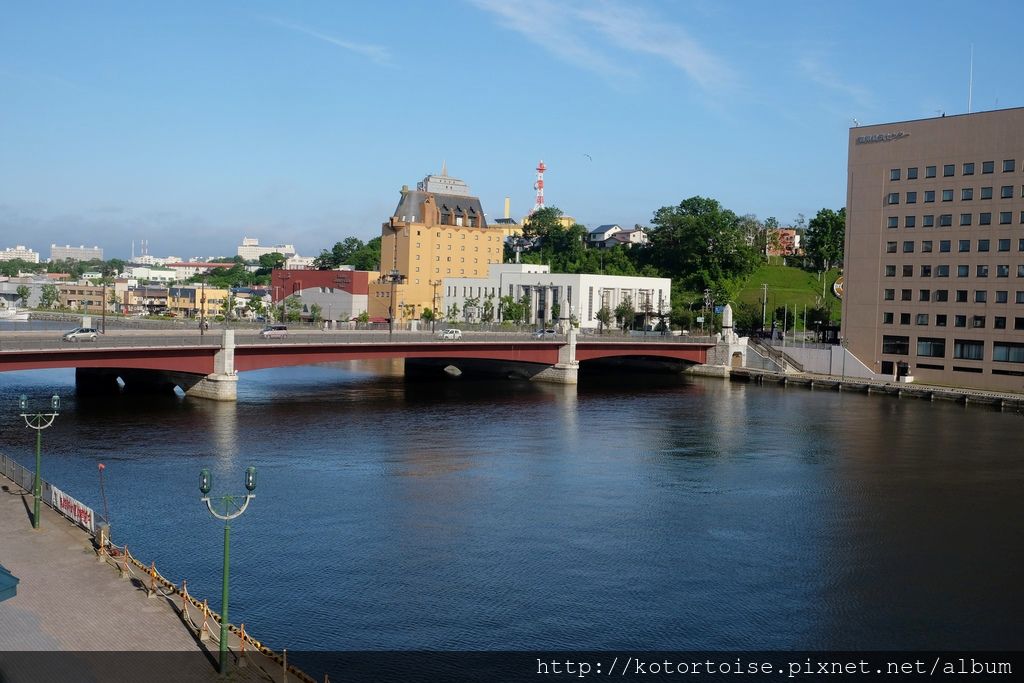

[0,453,316,683]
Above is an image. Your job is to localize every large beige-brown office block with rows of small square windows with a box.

[843,109,1024,391]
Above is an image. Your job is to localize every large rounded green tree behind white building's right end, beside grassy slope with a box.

[650,197,759,290]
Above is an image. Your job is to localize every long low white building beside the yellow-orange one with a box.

[438,263,672,330]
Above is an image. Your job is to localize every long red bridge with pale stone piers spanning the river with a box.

[0,330,715,400]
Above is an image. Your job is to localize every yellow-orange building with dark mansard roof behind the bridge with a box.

[369,170,506,323]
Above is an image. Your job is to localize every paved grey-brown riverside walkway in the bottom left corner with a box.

[0,475,295,683]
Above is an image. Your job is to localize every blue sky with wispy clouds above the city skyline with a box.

[0,0,1024,258]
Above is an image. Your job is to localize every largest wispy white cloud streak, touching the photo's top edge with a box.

[469,0,735,89]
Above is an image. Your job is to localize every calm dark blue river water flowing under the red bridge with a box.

[0,323,1024,650]
